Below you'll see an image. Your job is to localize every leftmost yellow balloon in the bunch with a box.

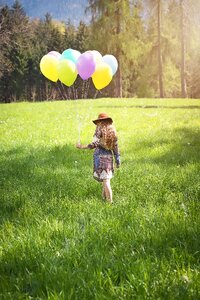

[40,55,58,82]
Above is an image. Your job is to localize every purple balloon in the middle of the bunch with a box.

[76,51,96,80]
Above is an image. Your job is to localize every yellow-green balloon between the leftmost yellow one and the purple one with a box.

[58,59,77,86]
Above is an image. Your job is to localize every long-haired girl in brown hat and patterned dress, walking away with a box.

[76,113,120,203]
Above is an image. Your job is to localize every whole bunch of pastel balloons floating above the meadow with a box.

[40,48,118,90]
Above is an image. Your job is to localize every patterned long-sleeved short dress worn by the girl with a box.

[87,127,120,182]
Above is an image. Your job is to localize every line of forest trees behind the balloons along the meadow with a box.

[0,0,200,103]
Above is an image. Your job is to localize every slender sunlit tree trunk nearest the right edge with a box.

[180,0,187,98]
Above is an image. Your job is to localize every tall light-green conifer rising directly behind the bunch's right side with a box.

[88,0,145,97]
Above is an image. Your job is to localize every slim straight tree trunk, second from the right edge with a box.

[158,0,164,98]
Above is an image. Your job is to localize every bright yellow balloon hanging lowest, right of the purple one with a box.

[92,63,112,90]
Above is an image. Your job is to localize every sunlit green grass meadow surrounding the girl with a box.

[0,99,200,300]
